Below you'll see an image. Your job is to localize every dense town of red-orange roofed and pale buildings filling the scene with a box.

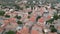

[0,0,60,34]
